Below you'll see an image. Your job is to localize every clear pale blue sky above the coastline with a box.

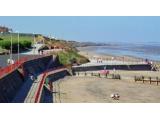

[0,16,160,43]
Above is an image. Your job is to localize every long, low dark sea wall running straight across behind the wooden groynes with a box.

[72,64,152,72]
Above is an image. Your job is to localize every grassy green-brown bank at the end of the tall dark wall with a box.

[58,50,88,65]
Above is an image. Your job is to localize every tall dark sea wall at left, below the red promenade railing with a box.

[0,56,61,103]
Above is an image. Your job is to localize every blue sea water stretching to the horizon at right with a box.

[79,42,160,61]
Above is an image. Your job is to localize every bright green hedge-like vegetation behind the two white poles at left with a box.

[0,33,33,51]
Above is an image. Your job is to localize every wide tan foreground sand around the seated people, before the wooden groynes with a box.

[53,76,160,103]
